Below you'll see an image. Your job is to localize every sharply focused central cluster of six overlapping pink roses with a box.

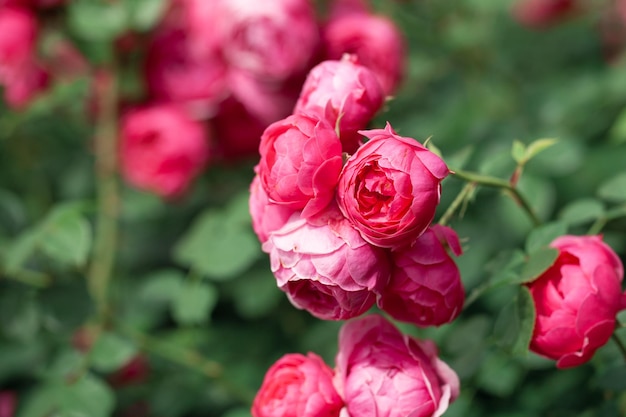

[250,55,464,326]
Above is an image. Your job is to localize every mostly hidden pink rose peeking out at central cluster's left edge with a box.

[249,169,295,243]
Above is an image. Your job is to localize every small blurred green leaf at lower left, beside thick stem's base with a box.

[89,332,137,372]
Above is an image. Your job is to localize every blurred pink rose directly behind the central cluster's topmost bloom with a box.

[322,12,406,95]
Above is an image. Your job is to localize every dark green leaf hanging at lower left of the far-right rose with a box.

[494,286,536,356]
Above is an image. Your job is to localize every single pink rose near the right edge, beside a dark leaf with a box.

[528,236,626,368]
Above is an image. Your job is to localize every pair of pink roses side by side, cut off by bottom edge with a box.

[252,315,459,417]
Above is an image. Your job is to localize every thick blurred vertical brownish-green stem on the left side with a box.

[87,64,119,324]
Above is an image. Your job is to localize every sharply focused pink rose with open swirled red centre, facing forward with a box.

[337,123,449,248]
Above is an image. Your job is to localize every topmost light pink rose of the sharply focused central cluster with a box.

[294,54,384,153]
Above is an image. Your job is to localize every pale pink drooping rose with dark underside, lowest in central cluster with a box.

[263,209,389,320]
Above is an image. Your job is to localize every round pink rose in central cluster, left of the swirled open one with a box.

[258,114,342,217]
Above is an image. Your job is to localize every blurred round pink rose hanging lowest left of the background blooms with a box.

[120,105,209,198]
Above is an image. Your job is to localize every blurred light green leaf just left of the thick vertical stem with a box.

[38,204,92,266]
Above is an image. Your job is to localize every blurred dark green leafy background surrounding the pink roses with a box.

[0,0,626,417]
